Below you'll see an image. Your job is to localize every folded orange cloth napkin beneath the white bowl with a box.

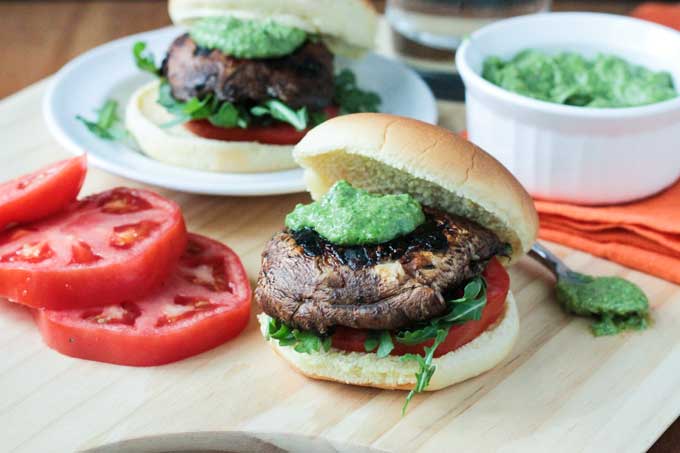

[535,181,680,284]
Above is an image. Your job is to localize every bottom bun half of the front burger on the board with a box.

[258,292,519,391]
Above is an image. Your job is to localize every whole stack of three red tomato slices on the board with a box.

[0,156,251,366]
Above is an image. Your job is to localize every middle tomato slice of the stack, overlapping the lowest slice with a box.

[0,188,186,309]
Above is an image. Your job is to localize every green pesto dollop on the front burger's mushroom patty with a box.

[286,181,425,245]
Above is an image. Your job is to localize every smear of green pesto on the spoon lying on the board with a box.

[556,275,649,336]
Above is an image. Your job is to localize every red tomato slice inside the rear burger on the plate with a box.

[185,106,339,145]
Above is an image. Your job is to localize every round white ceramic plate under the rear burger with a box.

[43,27,437,195]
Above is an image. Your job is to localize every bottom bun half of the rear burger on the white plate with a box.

[125,82,297,173]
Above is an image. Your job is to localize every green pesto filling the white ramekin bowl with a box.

[482,50,678,108]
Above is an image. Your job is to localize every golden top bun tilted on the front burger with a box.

[293,113,538,261]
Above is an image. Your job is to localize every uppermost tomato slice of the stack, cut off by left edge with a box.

[0,155,87,230]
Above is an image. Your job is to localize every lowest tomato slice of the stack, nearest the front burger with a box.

[34,234,251,366]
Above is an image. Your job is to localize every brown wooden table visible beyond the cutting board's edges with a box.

[0,0,680,453]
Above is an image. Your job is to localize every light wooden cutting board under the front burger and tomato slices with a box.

[0,82,680,452]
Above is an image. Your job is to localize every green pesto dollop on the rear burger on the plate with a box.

[189,17,307,58]
